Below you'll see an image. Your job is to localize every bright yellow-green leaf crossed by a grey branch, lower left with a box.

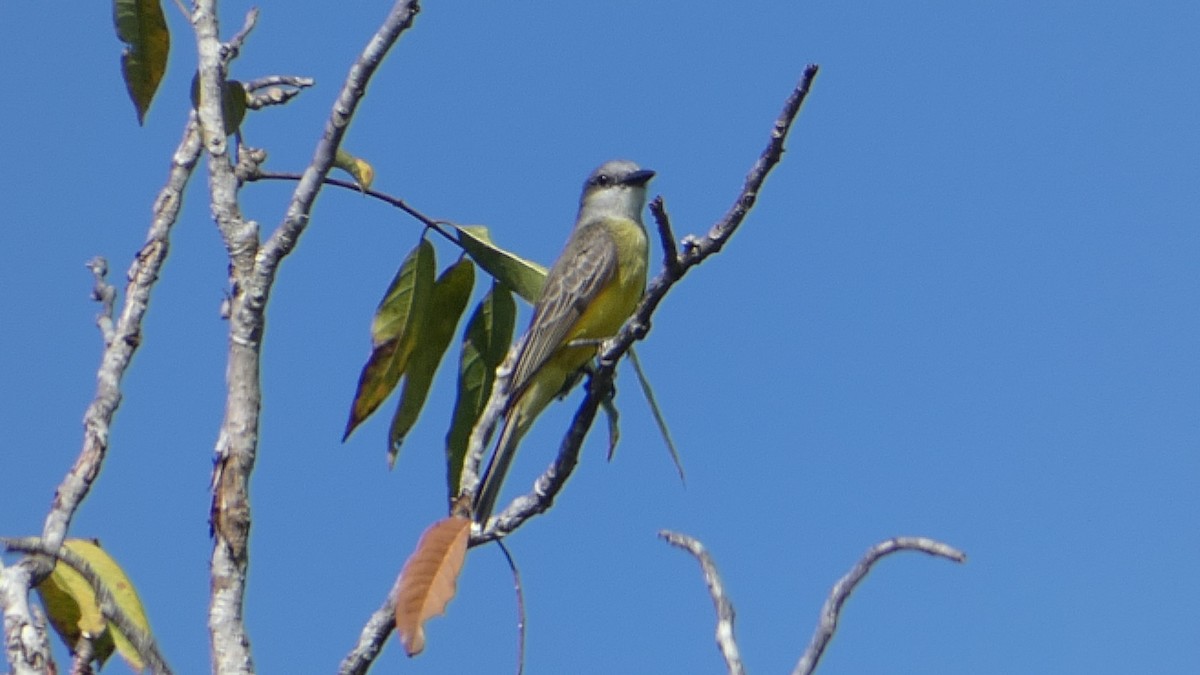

[37,539,150,671]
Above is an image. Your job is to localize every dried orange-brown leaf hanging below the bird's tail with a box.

[396,516,470,656]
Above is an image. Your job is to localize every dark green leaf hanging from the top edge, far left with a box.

[113,0,170,124]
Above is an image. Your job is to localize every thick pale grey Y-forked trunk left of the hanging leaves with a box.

[193,0,418,674]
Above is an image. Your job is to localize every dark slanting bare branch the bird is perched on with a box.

[463,64,820,545]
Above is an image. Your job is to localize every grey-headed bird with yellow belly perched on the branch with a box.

[475,160,654,525]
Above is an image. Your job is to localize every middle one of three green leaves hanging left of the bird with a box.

[388,257,475,467]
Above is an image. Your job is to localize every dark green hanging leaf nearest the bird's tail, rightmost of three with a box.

[446,280,517,500]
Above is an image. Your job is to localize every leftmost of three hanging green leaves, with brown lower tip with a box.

[342,237,437,441]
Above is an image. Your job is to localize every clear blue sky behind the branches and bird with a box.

[0,0,1200,674]
